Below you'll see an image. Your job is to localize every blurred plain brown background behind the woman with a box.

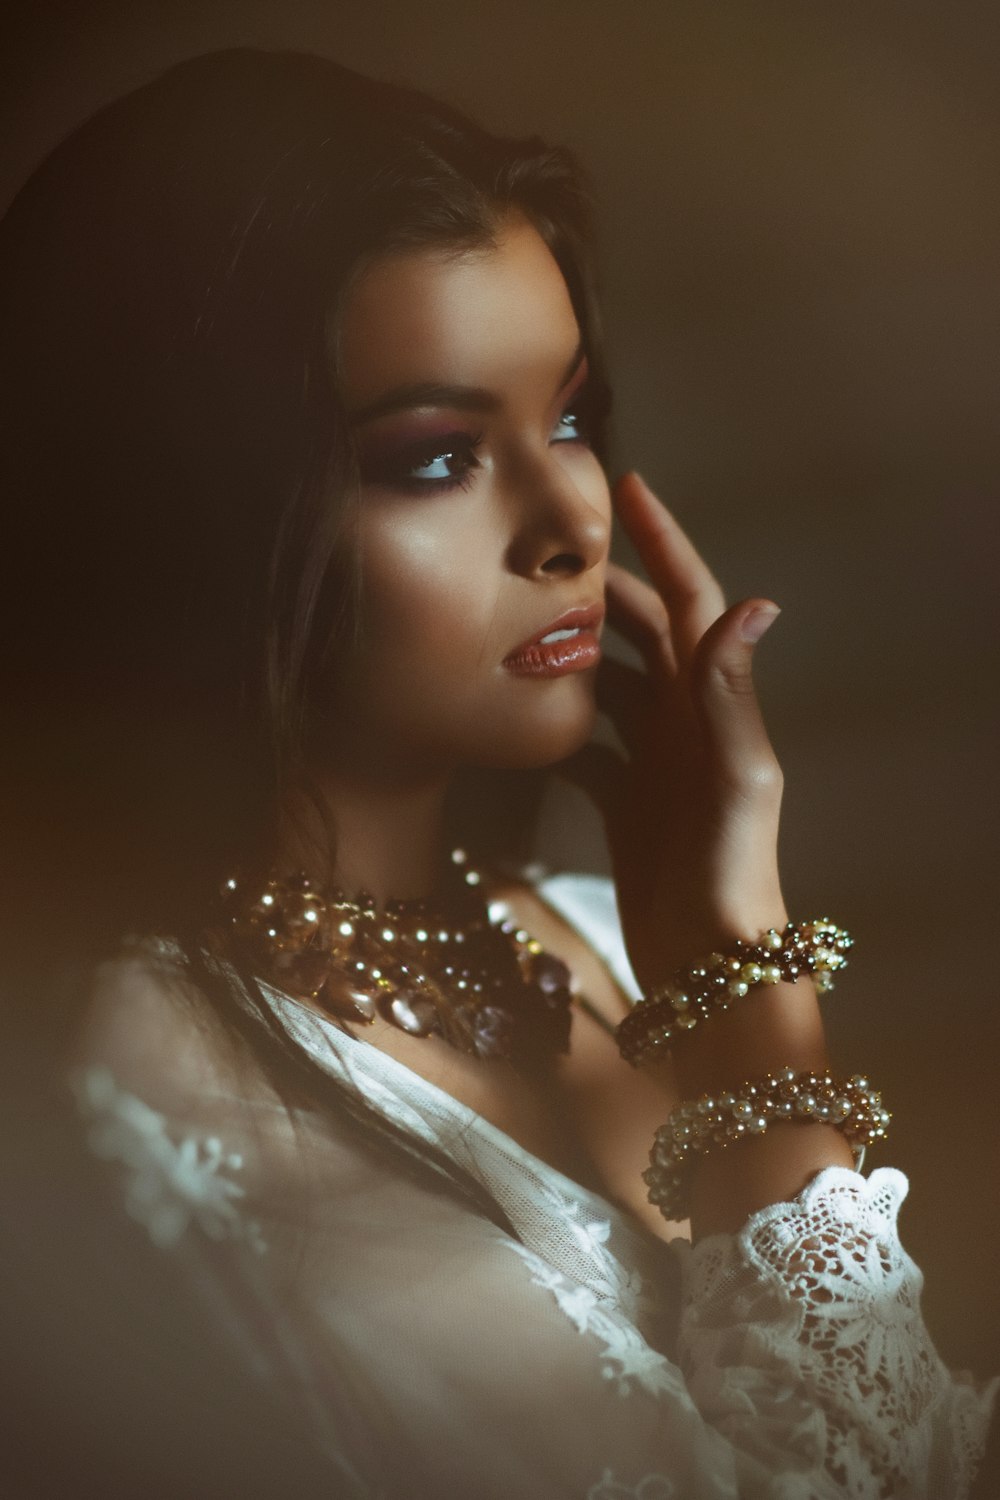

[0,0,1000,1373]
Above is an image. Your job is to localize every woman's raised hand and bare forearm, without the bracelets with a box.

[565,474,852,1236]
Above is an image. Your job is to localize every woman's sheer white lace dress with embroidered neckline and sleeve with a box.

[72,876,996,1500]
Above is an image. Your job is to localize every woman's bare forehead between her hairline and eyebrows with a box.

[340,221,580,407]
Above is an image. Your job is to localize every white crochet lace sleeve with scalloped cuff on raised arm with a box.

[681,1167,996,1500]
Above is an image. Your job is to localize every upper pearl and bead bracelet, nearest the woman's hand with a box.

[615,918,853,1067]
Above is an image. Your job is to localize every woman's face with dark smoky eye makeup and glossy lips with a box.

[334,219,612,774]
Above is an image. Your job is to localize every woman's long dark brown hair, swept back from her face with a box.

[0,50,611,1206]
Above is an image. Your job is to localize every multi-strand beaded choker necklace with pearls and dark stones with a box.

[222,849,571,1067]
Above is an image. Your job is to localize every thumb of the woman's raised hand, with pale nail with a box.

[691,599,781,800]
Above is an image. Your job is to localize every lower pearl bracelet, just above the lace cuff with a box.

[642,1068,891,1220]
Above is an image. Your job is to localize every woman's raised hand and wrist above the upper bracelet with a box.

[565,473,787,989]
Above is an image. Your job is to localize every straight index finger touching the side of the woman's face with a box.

[615,470,726,665]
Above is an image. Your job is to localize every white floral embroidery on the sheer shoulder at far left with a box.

[70,1068,267,1254]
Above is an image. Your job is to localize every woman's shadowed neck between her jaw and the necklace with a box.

[279,773,448,905]
